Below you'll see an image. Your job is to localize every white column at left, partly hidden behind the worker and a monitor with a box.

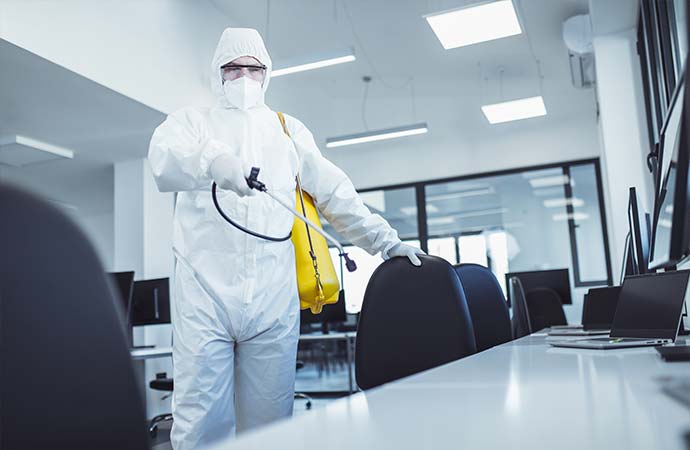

[114,159,174,418]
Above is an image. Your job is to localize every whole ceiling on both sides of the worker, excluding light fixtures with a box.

[0,0,596,212]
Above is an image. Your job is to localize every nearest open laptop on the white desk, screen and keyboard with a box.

[549,270,690,350]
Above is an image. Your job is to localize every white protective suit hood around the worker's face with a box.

[211,28,273,108]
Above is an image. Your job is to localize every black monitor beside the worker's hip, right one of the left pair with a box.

[130,278,170,326]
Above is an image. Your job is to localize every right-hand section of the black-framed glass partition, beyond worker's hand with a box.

[424,161,611,286]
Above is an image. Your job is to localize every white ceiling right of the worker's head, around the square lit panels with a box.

[213,0,595,141]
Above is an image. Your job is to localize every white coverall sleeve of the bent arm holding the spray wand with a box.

[149,108,228,192]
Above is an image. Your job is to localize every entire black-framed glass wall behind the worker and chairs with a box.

[325,160,611,313]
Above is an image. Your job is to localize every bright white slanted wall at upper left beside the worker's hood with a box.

[0,0,231,113]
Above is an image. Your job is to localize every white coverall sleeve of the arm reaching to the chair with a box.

[286,116,400,255]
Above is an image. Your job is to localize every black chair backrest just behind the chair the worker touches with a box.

[455,264,513,352]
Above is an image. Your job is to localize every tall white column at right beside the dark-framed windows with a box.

[593,29,654,280]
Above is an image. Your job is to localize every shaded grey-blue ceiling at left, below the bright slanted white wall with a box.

[0,39,165,212]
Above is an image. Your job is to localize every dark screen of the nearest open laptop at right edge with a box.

[611,270,690,339]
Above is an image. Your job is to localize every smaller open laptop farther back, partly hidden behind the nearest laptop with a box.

[549,286,621,337]
